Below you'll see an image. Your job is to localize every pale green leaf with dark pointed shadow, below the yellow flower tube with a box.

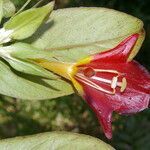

[0,60,73,100]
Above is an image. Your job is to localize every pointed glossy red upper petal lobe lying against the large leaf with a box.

[93,34,139,62]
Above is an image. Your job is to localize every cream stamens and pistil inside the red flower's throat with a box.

[75,68,127,94]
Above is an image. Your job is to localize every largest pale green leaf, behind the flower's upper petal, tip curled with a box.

[28,8,144,62]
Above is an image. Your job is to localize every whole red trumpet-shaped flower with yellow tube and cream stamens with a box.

[34,34,150,139]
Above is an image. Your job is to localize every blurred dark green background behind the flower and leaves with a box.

[0,0,150,150]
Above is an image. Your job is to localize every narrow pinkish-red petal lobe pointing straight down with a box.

[83,85,115,139]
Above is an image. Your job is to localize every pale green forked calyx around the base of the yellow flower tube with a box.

[0,43,58,79]
